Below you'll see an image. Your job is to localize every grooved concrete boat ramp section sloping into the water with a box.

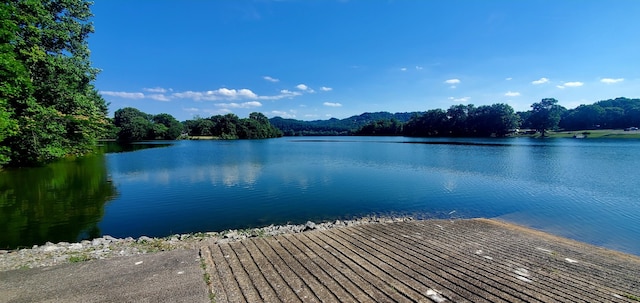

[200,219,640,303]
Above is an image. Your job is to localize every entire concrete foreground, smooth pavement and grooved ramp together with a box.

[0,219,640,303]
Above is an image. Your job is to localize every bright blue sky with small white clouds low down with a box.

[89,0,640,121]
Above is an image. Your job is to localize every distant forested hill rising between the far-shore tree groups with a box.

[269,112,424,136]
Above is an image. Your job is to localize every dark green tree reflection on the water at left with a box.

[0,155,117,248]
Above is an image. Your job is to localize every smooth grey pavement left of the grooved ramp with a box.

[0,249,211,303]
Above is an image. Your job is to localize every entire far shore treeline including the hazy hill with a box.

[106,98,640,142]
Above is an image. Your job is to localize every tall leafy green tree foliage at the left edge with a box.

[0,0,107,166]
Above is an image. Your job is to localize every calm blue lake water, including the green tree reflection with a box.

[0,137,640,255]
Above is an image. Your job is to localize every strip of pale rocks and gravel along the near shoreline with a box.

[0,216,414,271]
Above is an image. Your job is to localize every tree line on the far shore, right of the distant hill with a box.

[353,97,640,137]
